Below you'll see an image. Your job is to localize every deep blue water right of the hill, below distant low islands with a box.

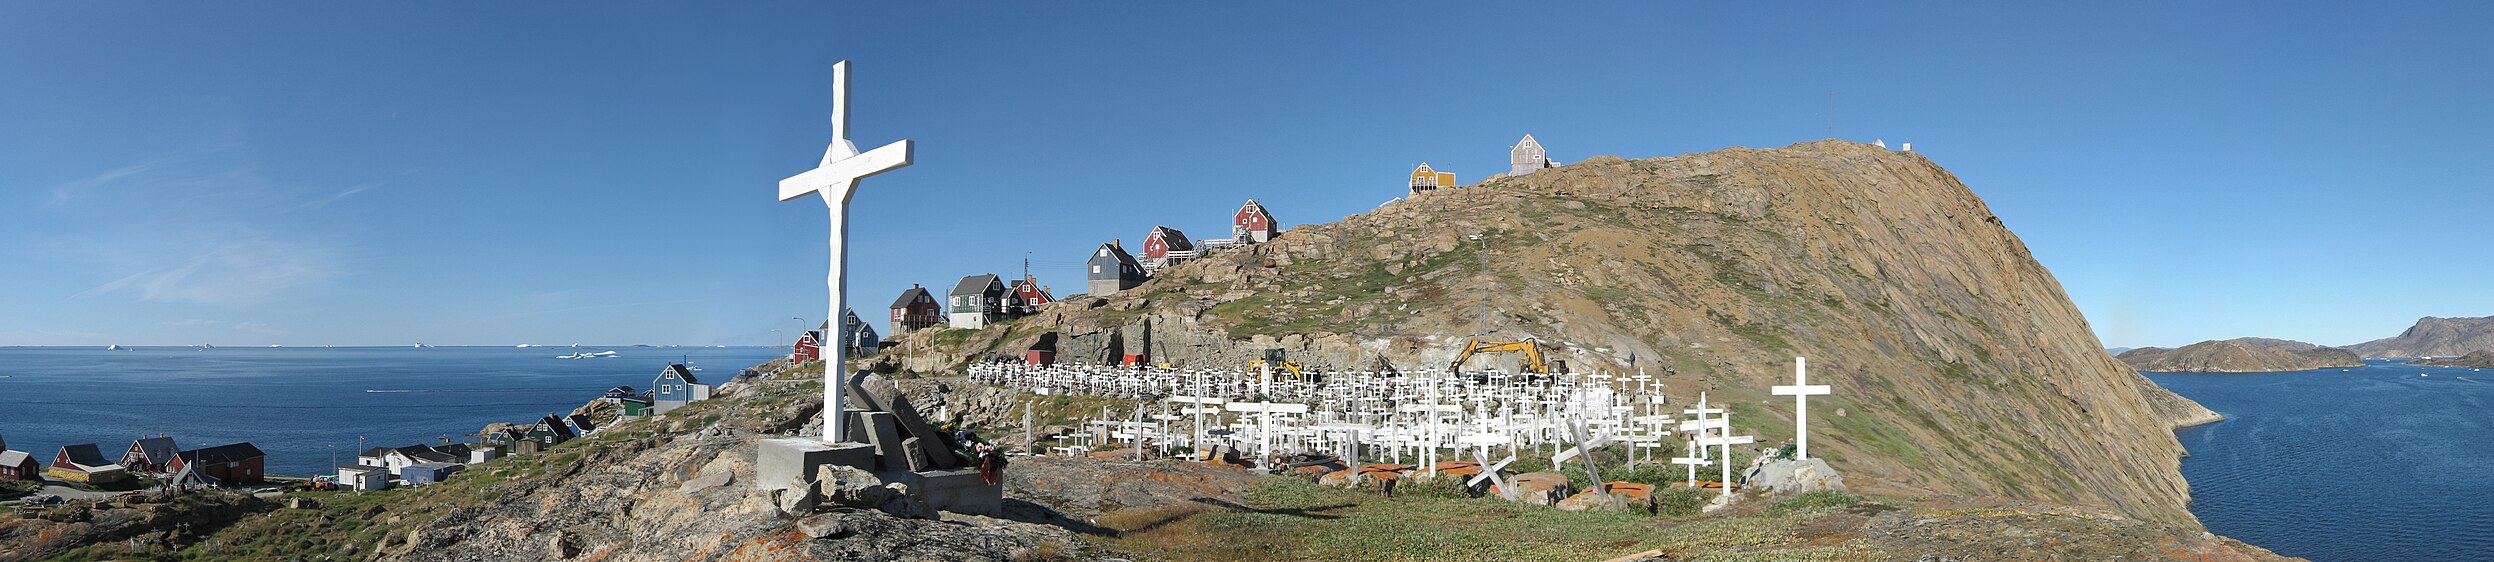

[2147,360,2494,562]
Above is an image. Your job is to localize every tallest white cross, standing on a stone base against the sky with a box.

[781,60,913,442]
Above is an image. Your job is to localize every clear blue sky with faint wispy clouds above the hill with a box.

[0,2,2494,345]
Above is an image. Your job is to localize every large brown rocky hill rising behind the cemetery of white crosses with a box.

[875,140,2210,527]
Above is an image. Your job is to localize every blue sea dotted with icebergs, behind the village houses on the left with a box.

[0,347,786,475]
